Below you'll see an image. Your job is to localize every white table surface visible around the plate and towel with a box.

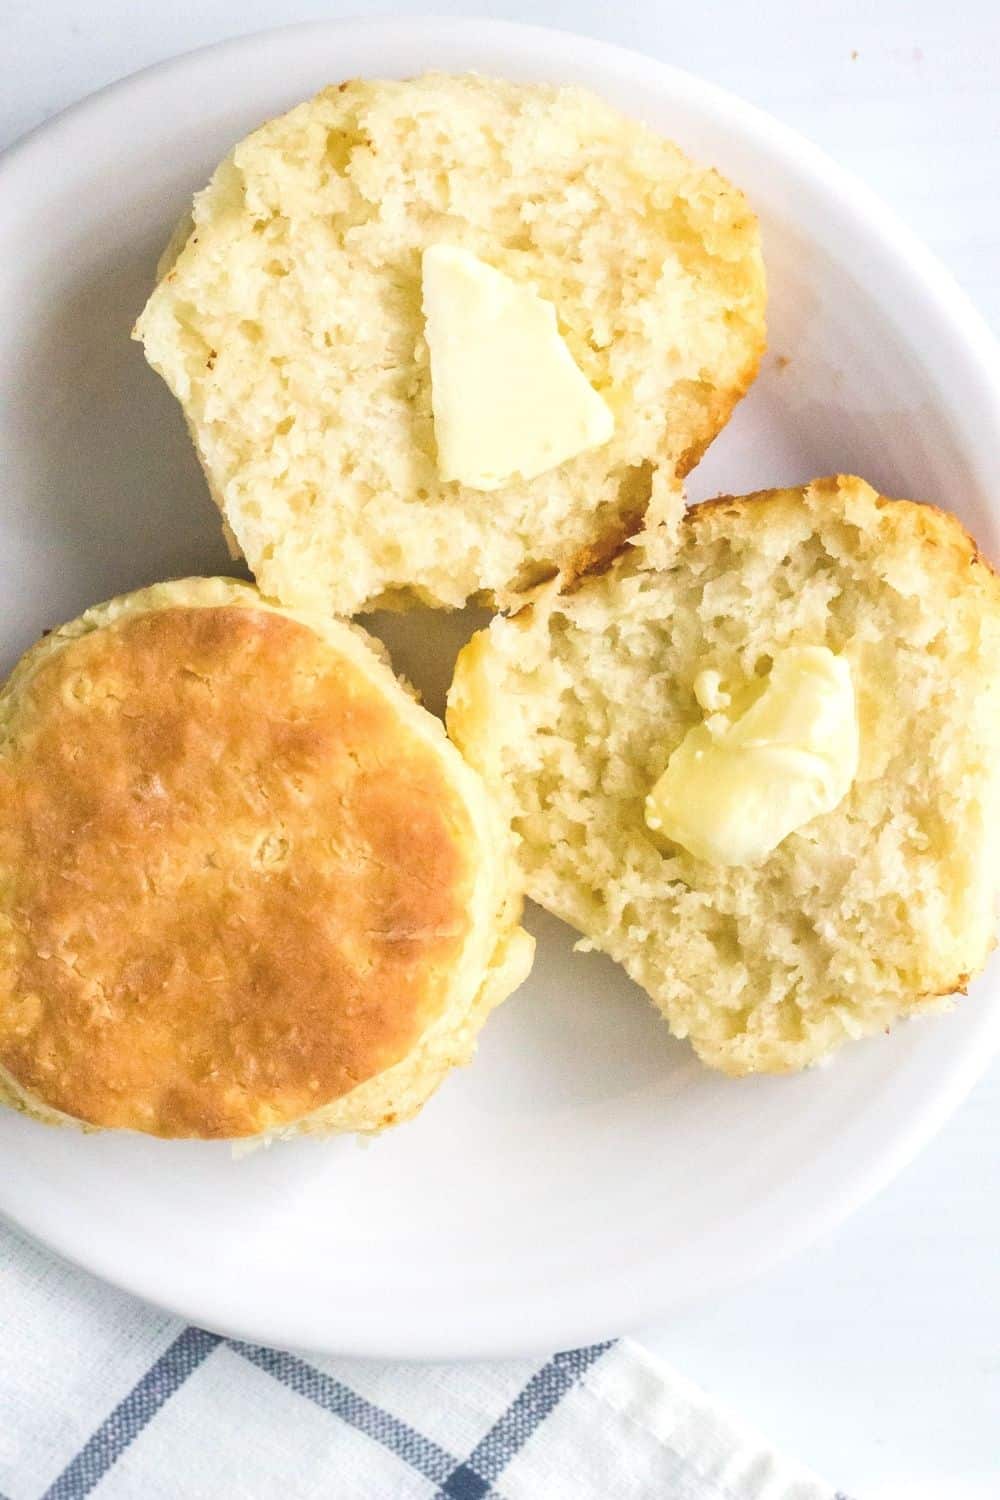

[0,0,1000,1500]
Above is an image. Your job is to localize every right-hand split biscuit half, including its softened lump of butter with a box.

[448,477,1000,1074]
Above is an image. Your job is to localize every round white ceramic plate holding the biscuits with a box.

[0,20,1000,1358]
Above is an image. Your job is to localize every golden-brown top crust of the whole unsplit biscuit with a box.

[0,608,475,1137]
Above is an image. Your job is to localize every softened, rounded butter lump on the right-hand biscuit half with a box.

[646,647,858,866]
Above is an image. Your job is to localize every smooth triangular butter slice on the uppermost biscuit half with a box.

[423,245,615,489]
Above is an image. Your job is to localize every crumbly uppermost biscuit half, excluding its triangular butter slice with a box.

[136,75,765,615]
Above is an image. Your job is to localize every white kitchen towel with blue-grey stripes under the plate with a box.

[0,1227,846,1500]
